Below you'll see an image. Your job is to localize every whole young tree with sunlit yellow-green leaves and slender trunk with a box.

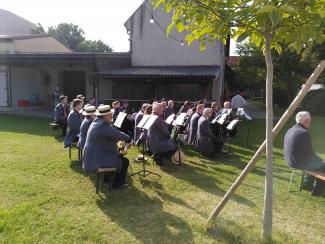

[152,0,325,239]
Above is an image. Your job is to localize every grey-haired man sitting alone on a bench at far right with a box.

[283,111,325,196]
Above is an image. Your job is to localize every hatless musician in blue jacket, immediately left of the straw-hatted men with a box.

[64,99,83,147]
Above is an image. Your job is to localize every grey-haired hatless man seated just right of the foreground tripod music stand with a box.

[148,103,177,166]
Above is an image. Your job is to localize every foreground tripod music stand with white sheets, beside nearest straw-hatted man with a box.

[130,115,161,179]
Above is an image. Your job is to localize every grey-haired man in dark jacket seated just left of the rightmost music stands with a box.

[197,108,222,158]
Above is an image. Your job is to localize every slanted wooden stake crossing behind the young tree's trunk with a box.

[206,60,325,224]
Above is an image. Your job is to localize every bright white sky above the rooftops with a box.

[0,0,233,52]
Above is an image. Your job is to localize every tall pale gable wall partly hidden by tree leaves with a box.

[125,2,224,66]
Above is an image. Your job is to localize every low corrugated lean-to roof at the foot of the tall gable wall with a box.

[96,66,220,78]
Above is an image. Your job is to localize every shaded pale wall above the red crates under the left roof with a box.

[11,67,46,107]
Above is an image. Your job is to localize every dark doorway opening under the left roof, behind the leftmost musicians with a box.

[62,71,86,101]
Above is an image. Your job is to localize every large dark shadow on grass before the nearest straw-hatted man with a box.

[97,187,194,243]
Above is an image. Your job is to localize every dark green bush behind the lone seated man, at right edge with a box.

[302,90,325,116]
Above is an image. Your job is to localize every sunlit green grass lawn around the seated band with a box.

[0,114,325,243]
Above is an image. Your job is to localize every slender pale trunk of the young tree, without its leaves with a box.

[263,34,273,239]
